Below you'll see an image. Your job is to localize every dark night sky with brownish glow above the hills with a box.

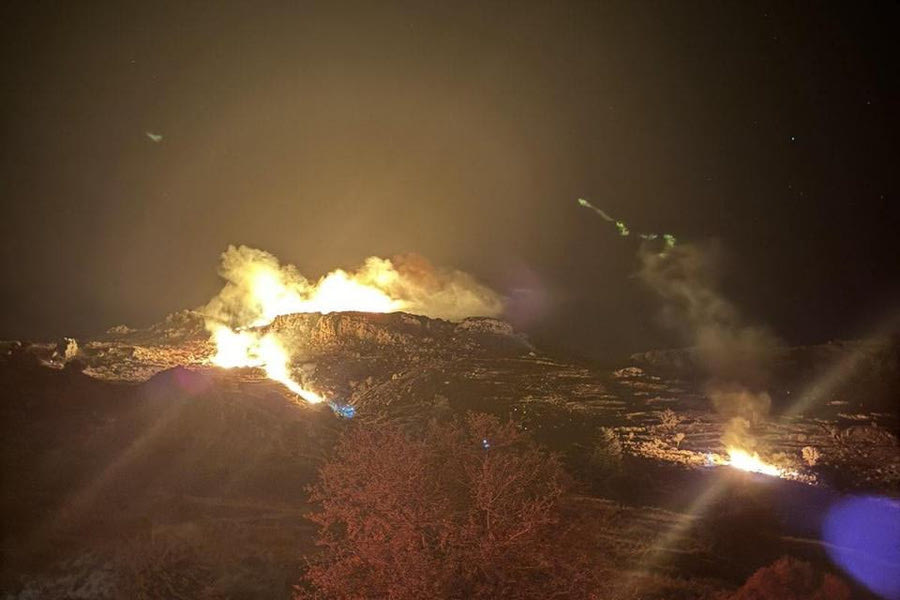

[0,1,900,356]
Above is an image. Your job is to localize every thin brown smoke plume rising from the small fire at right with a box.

[639,243,778,448]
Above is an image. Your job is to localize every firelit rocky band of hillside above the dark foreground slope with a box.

[14,311,900,491]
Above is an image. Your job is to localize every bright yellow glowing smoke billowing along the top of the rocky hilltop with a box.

[203,246,503,327]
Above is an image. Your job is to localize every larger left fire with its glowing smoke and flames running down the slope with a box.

[203,246,503,404]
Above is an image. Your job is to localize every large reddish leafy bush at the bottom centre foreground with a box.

[297,415,593,600]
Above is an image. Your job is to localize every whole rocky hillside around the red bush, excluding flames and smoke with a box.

[0,311,900,598]
